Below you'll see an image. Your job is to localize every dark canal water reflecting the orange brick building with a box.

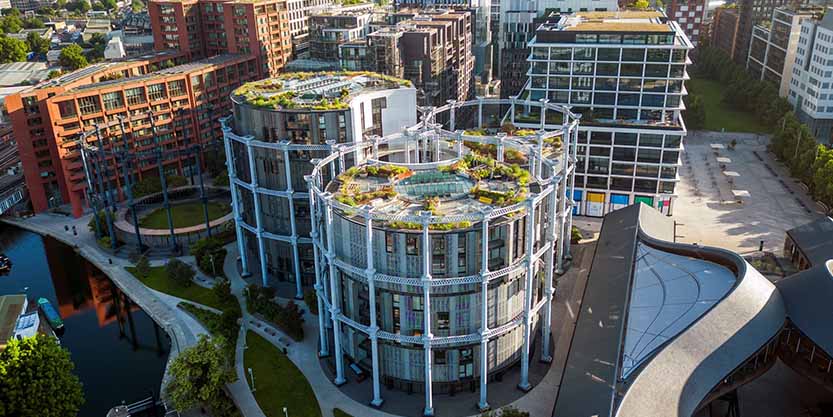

[0,224,170,417]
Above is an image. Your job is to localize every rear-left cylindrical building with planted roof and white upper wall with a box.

[223,72,417,298]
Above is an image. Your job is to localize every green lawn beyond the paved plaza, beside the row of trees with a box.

[686,78,766,133]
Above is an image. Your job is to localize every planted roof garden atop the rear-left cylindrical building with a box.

[232,71,411,110]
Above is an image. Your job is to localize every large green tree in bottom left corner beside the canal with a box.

[0,335,84,417]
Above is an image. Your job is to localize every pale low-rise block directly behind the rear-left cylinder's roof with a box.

[309,3,373,62]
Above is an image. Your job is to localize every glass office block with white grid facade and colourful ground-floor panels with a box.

[515,11,692,216]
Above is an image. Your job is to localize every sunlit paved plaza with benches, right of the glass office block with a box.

[674,132,822,256]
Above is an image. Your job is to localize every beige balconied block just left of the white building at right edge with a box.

[746,7,824,97]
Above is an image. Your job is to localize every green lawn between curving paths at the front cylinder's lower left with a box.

[243,331,321,417]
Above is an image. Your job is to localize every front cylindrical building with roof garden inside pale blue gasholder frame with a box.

[307,99,578,415]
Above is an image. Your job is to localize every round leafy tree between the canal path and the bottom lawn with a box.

[166,335,235,411]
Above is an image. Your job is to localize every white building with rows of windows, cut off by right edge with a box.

[787,8,833,144]
